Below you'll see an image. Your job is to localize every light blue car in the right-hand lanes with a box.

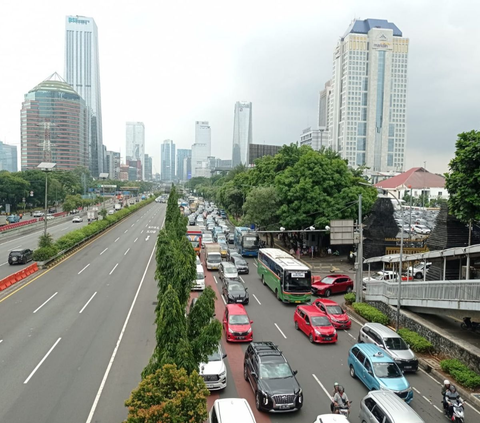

[348,344,413,404]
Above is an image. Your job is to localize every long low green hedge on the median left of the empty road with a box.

[33,197,155,261]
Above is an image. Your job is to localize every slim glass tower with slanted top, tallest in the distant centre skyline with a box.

[232,101,252,167]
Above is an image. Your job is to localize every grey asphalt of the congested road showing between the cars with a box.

[204,255,480,423]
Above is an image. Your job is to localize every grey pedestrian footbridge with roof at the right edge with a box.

[364,245,480,321]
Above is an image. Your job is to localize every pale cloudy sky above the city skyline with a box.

[0,0,480,173]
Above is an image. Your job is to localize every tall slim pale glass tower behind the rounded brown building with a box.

[65,16,103,176]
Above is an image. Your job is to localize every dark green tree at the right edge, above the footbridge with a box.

[445,131,480,223]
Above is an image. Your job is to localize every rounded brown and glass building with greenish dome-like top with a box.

[21,73,90,170]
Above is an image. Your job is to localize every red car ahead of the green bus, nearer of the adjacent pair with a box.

[293,305,337,344]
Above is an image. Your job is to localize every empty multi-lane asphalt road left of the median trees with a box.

[0,204,164,423]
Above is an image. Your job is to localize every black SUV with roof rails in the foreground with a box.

[243,341,303,412]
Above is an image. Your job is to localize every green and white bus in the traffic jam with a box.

[257,248,312,303]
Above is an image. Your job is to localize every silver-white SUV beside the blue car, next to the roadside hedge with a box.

[358,323,418,372]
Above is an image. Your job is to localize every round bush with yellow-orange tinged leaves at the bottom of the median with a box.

[125,364,210,423]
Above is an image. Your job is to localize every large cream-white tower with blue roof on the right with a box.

[326,19,409,172]
